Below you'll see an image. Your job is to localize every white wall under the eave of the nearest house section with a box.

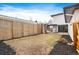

[68,9,79,40]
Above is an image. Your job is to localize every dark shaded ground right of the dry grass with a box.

[50,35,78,55]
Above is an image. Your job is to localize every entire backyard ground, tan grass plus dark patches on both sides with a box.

[0,33,77,55]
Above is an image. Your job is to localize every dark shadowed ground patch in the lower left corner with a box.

[0,41,16,55]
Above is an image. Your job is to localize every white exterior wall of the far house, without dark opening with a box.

[48,14,67,32]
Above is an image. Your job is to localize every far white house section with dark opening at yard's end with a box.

[48,13,68,32]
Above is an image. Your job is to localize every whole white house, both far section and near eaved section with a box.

[48,4,79,41]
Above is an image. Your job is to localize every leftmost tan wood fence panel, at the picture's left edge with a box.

[0,20,12,40]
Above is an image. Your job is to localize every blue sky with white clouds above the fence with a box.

[0,3,73,23]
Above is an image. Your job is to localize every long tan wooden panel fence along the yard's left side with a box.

[0,19,43,40]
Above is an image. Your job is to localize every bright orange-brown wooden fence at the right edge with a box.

[73,22,79,53]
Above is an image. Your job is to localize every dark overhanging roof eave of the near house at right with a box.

[64,4,79,23]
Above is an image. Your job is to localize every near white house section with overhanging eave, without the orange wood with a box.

[64,4,79,40]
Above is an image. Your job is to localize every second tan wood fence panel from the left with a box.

[13,21,23,38]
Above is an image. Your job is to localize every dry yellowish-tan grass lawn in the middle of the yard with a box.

[4,34,61,55]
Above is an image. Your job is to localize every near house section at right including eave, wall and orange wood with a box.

[64,4,79,53]
